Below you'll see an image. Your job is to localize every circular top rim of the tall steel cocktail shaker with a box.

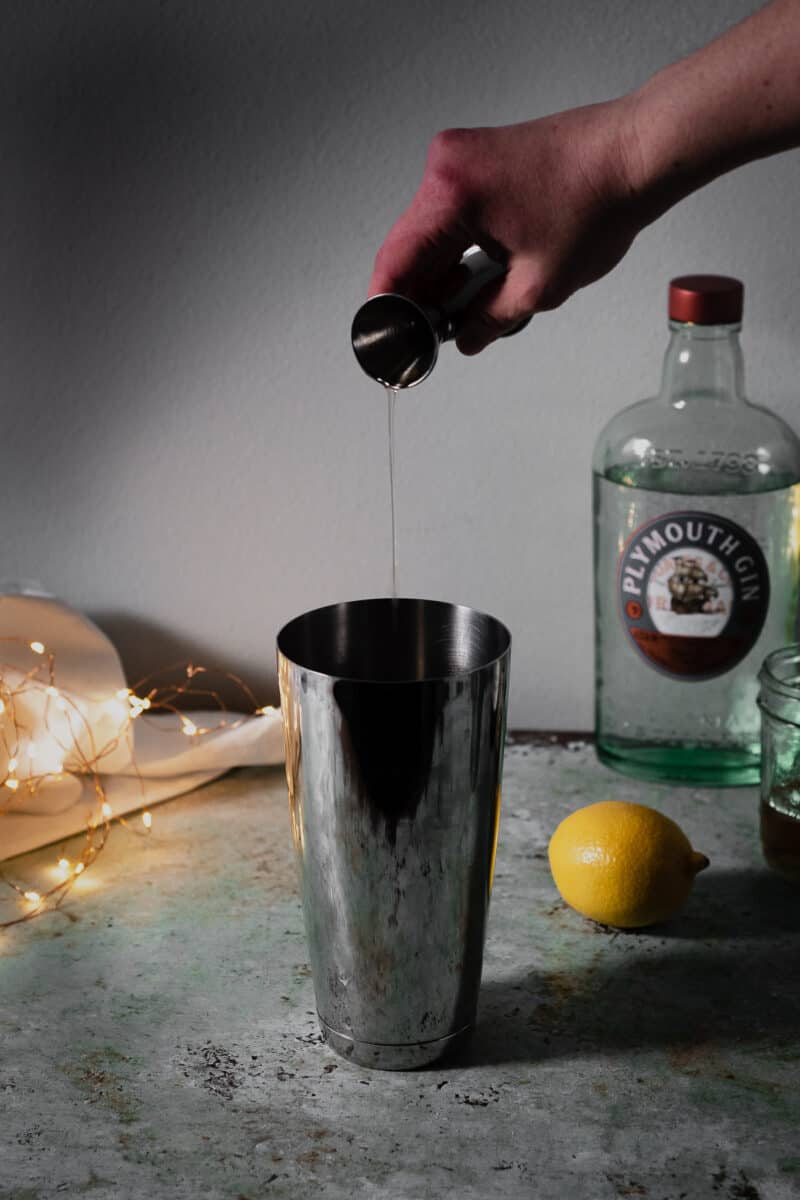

[276,596,511,688]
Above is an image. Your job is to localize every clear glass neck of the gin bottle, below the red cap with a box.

[661,320,745,408]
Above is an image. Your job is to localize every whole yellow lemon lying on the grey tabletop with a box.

[549,800,709,929]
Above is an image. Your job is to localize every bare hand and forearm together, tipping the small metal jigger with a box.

[369,0,800,354]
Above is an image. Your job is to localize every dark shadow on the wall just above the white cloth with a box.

[91,612,278,712]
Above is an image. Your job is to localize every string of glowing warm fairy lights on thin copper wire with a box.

[0,637,276,929]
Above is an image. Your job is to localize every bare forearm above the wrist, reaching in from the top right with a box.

[626,0,800,222]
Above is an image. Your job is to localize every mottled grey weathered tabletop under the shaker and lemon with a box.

[0,744,800,1200]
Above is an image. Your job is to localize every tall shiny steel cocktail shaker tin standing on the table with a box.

[278,599,511,1069]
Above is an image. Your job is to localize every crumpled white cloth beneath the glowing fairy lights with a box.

[0,595,283,860]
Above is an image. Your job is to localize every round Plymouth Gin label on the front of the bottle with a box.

[616,511,770,679]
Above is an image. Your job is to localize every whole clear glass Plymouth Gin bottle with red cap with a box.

[593,275,800,784]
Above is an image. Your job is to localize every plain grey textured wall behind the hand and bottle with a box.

[0,0,800,728]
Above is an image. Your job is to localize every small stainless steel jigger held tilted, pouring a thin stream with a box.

[350,246,528,388]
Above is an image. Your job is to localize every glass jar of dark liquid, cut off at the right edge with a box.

[758,642,800,880]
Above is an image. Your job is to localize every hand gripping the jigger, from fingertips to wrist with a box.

[369,98,645,354]
